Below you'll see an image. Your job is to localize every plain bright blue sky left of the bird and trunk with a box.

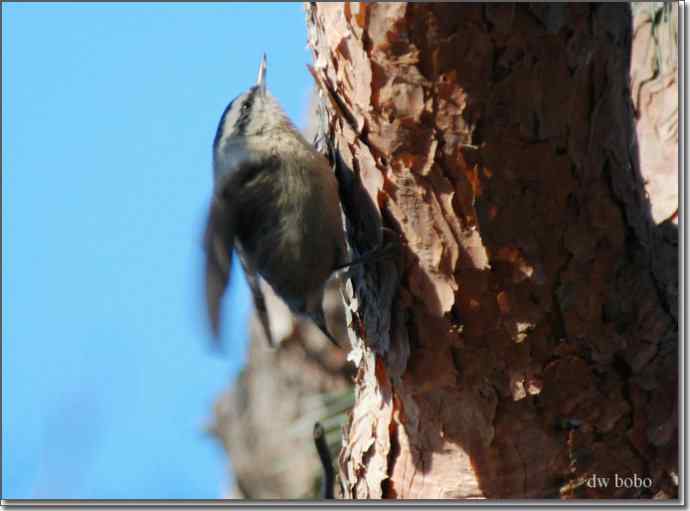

[2,3,311,499]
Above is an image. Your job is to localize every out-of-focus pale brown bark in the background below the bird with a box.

[209,286,352,499]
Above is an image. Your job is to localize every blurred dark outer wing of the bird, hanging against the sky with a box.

[204,197,235,340]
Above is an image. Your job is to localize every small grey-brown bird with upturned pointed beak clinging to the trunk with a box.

[204,55,352,345]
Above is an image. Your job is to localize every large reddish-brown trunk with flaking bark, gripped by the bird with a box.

[307,3,678,498]
